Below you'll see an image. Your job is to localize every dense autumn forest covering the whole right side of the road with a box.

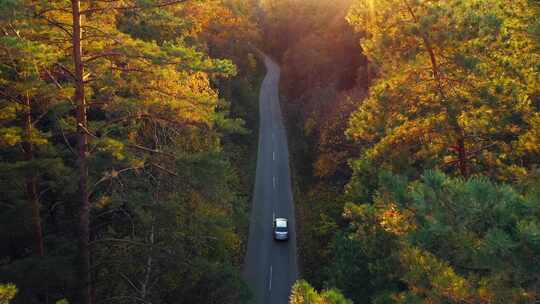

[266,0,540,303]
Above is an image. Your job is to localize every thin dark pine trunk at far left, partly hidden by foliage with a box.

[22,92,45,257]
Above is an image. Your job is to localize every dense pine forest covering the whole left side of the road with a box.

[0,0,261,303]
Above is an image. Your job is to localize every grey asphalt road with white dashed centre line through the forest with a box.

[243,57,298,304]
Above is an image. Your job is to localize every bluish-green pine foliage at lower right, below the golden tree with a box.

[336,171,540,303]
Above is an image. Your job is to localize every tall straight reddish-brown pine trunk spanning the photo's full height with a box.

[71,0,92,304]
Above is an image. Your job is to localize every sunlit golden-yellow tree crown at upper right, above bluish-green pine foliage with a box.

[347,0,540,180]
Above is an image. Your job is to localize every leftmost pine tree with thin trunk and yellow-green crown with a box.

[0,2,66,256]
